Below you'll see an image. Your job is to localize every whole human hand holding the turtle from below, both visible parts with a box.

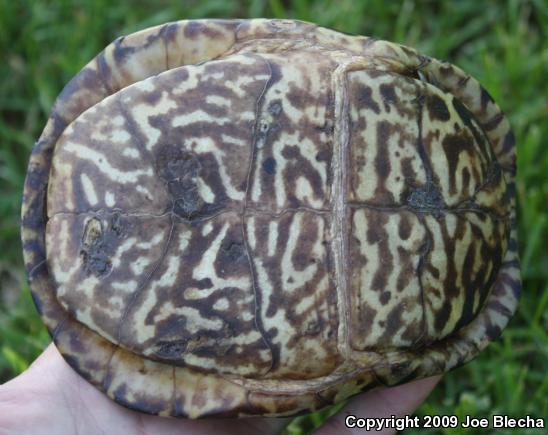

[0,344,440,435]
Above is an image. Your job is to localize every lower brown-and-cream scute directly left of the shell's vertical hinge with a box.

[245,210,342,379]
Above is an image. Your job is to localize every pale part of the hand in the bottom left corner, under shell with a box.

[0,344,290,435]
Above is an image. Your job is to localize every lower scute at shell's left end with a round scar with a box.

[46,212,171,343]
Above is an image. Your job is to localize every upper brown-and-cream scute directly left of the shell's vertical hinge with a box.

[248,52,336,212]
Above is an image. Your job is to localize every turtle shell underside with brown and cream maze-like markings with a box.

[22,19,521,418]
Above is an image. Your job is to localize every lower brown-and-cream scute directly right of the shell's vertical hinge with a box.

[349,207,427,351]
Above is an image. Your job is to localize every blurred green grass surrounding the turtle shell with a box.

[0,0,548,433]
